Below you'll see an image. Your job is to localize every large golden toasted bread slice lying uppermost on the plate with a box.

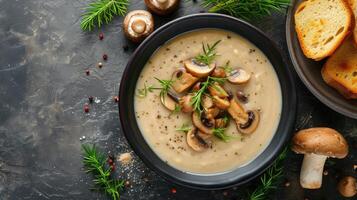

[295,0,354,60]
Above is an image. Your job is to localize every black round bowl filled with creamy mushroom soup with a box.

[119,14,296,189]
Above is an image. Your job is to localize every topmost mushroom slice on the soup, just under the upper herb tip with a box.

[183,59,216,78]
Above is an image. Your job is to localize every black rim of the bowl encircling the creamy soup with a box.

[118,13,297,190]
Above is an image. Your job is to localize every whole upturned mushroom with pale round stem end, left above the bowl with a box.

[123,10,154,42]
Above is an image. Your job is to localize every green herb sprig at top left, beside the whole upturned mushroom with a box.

[81,0,129,31]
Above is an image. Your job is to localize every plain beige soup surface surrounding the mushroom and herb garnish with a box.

[134,29,282,174]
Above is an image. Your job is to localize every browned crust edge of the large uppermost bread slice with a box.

[295,0,355,61]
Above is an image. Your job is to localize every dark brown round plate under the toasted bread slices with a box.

[286,0,357,119]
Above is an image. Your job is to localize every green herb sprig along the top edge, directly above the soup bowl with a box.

[203,0,290,20]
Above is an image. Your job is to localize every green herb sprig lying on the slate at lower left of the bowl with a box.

[82,144,124,200]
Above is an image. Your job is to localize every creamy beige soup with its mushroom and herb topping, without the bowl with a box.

[134,29,282,173]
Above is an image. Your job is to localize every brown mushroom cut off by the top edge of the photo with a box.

[145,0,180,15]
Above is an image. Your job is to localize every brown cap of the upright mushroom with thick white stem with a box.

[292,127,348,158]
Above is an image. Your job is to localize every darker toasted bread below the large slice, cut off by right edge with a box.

[321,37,357,99]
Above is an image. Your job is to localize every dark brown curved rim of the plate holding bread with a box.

[285,0,357,119]
